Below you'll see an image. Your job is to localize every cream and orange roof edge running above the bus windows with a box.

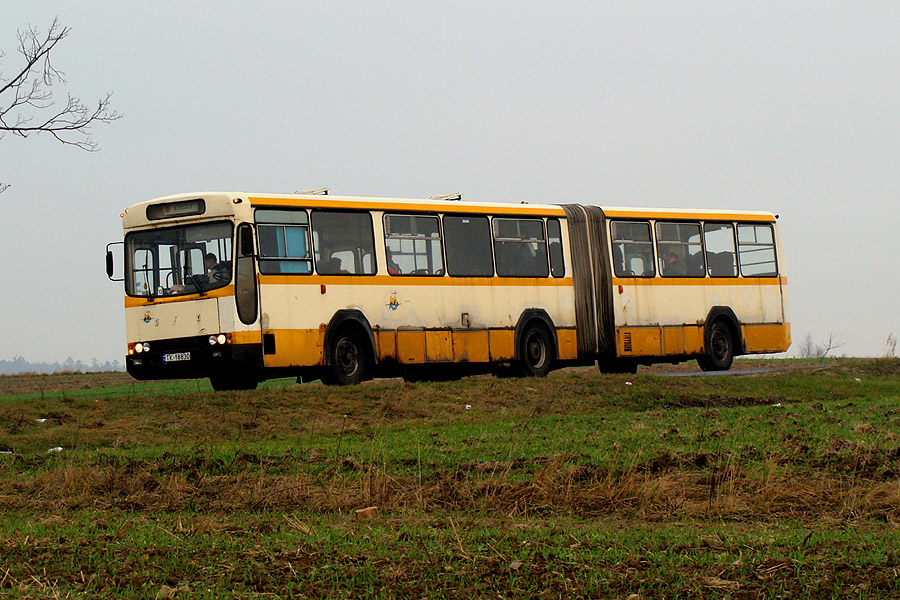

[122,191,777,229]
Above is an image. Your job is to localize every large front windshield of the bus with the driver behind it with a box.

[125,222,233,297]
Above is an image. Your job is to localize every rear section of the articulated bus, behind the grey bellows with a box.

[607,209,790,370]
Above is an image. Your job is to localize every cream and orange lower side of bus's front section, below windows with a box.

[253,275,577,367]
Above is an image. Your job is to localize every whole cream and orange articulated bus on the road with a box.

[107,192,790,390]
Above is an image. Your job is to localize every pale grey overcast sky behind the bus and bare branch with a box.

[0,0,900,361]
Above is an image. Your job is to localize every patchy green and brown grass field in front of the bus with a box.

[0,359,900,600]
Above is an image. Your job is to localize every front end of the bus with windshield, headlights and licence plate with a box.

[123,195,262,389]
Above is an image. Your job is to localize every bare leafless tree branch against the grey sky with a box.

[0,18,121,193]
